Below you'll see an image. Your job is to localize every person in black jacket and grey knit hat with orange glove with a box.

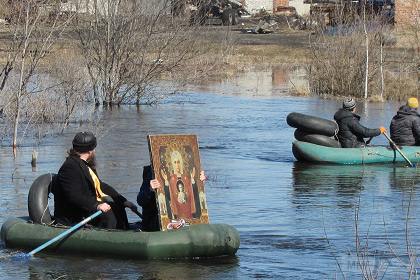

[334,98,386,148]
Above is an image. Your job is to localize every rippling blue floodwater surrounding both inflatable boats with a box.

[0,67,420,279]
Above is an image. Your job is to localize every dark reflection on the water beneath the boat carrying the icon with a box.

[24,256,238,280]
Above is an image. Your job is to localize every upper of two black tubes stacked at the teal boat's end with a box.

[286,112,338,136]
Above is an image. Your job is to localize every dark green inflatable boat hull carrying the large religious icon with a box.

[1,217,239,259]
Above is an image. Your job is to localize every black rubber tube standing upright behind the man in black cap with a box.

[28,173,55,224]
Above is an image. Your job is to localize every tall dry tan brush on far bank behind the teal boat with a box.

[310,9,419,101]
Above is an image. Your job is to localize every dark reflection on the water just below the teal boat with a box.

[292,162,420,217]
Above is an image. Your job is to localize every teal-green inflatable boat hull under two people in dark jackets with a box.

[292,141,420,164]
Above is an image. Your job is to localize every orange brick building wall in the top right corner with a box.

[395,0,420,26]
